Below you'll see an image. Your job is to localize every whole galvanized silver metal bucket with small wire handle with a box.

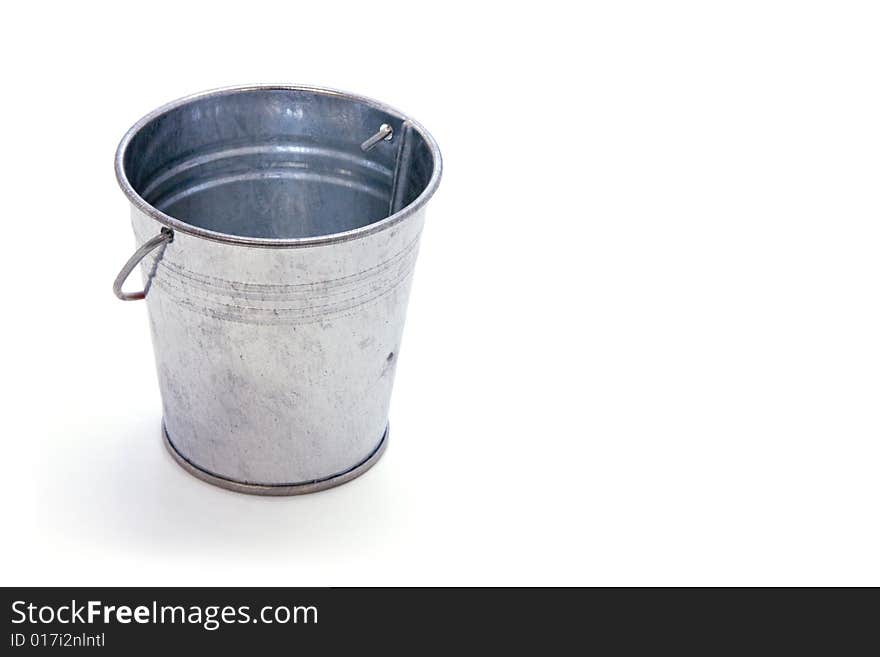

[113,85,441,495]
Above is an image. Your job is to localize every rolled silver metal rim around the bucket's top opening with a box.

[115,84,443,248]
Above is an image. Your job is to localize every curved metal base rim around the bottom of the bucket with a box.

[162,420,390,496]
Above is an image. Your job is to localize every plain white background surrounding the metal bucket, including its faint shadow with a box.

[0,0,880,585]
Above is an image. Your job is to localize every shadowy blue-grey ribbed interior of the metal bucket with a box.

[122,88,436,239]
